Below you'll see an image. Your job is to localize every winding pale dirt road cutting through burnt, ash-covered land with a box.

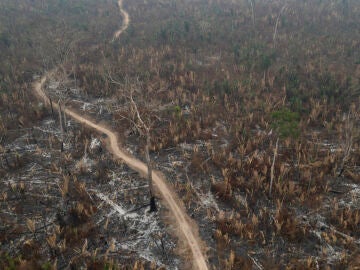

[33,0,208,270]
